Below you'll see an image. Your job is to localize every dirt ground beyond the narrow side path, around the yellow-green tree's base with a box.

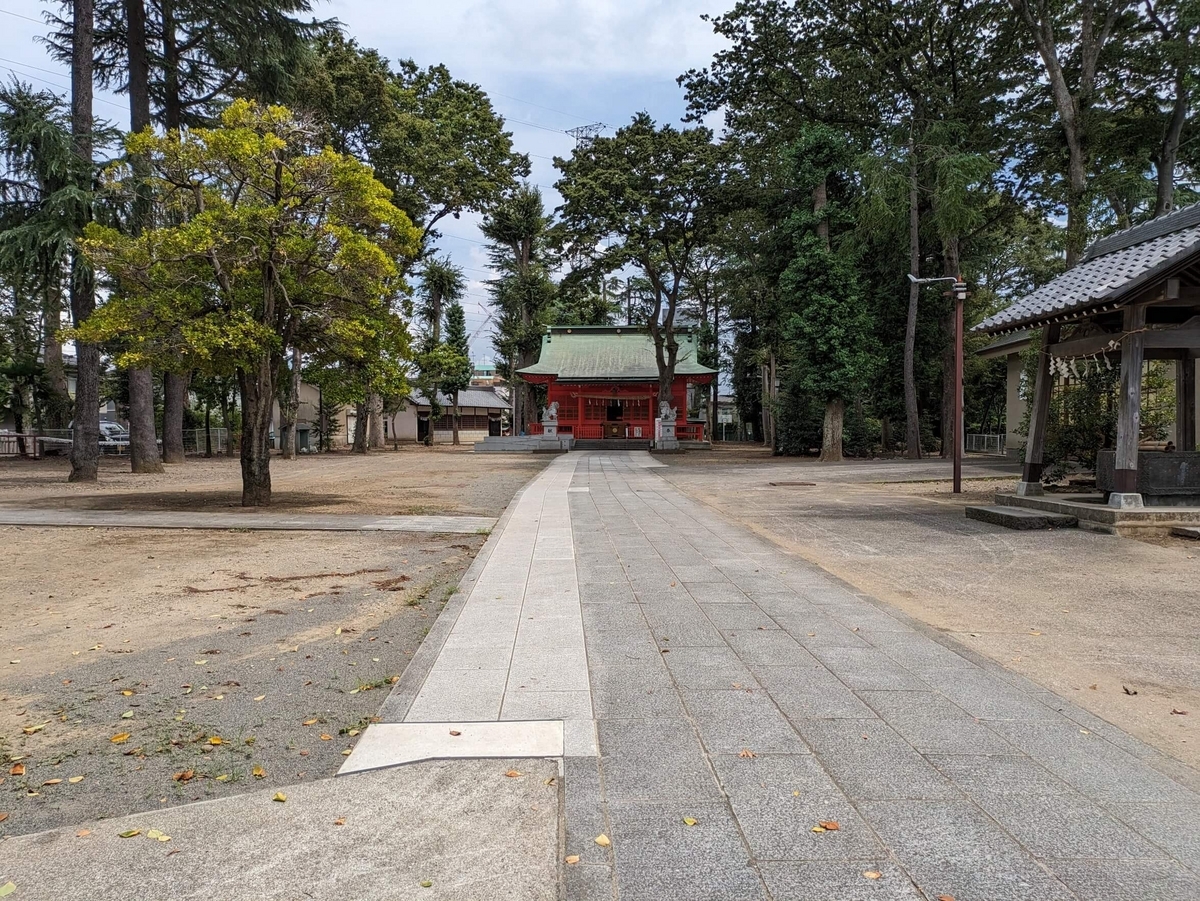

[0,445,546,516]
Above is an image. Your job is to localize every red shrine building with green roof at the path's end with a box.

[517,325,716,442]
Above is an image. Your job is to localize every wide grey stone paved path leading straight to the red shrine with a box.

[385,453,1200,901]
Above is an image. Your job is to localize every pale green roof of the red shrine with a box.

[518,325,716,382]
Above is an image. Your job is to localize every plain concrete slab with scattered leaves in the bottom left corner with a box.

[0,759,559,901]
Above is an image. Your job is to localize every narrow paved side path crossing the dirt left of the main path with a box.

[0,506,496,535]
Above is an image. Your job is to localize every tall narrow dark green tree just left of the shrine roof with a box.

[480,185,556,432]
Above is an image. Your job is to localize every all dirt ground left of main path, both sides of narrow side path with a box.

[0,449,545,835]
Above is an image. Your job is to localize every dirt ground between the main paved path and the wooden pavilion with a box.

[656,448,1200,785]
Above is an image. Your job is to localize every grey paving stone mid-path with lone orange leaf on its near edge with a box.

[683,689,808,753]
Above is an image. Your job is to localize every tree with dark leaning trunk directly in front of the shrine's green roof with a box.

[554,113,722,403]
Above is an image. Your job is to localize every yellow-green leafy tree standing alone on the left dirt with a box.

[79,101,419,506]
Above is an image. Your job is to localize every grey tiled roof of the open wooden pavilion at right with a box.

[974,204,1200,332]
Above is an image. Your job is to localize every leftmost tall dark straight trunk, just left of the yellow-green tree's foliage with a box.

[68,0,100,482]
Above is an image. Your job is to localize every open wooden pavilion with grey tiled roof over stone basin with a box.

[977,204,1200,509]
